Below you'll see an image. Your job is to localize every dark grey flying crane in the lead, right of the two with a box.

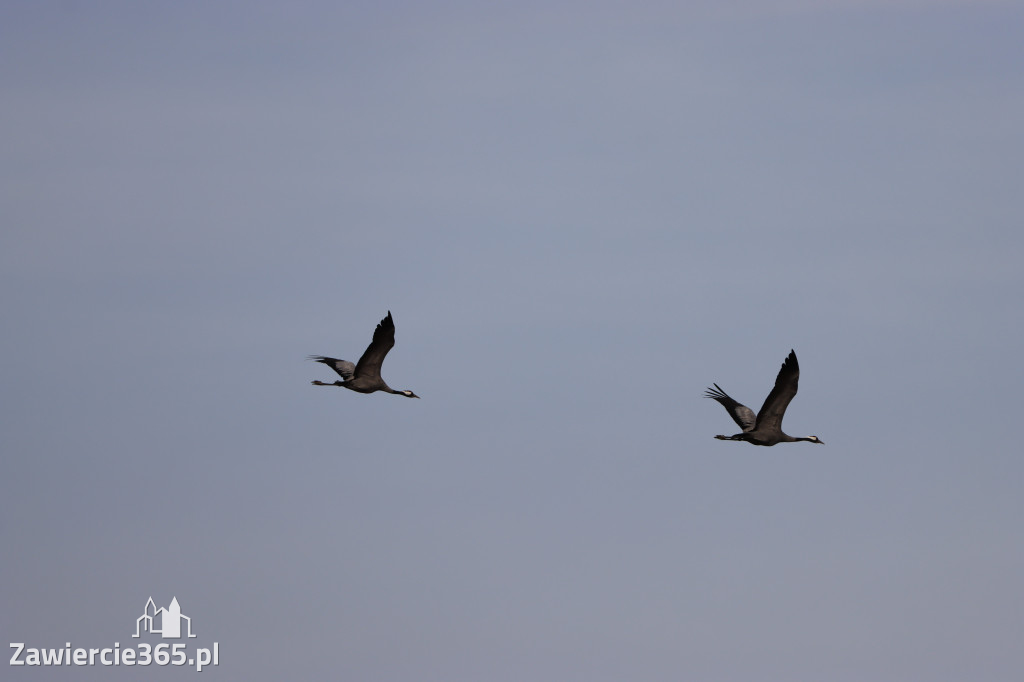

[705,350,824,445]
